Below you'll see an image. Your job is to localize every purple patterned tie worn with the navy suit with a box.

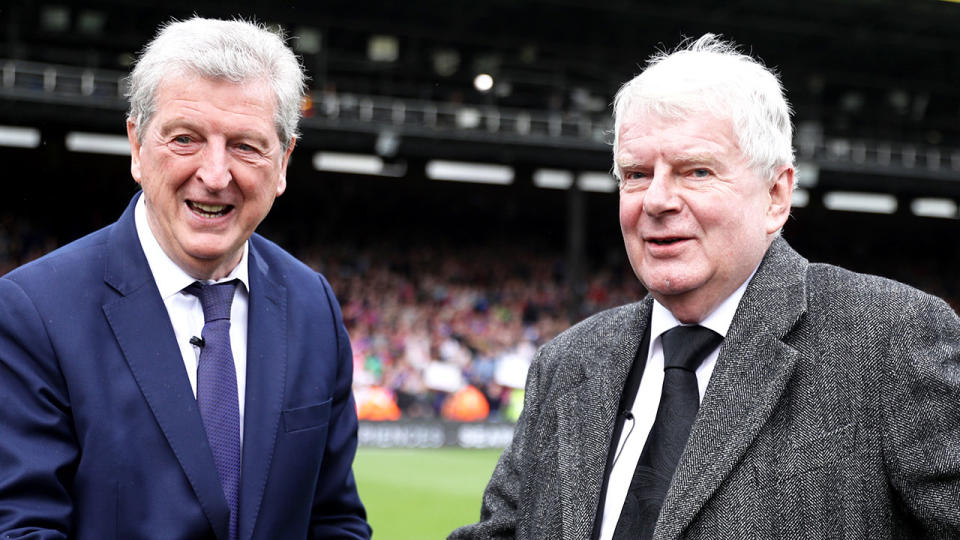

[184,280,240,540]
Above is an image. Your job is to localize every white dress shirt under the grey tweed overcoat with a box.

[600,269,756,540]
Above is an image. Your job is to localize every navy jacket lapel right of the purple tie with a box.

[238,240,287,539]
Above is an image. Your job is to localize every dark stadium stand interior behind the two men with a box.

[0,0,960,420]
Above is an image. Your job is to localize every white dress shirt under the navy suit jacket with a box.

[133,195,250,445]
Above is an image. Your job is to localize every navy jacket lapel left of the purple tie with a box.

[103,197,230,538]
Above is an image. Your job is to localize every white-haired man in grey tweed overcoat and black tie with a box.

[450,34,960,540]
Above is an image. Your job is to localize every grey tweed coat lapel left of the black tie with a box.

[557,297,653,539]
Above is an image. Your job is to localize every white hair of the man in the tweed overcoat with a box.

[613,34,794,180]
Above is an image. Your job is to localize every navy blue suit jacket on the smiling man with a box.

[0,197,370,540]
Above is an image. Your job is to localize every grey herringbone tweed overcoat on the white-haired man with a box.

[450,239,960,540]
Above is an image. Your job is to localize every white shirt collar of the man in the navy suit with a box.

[133,194,250,300]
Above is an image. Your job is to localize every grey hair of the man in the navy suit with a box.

[126,17,306,149]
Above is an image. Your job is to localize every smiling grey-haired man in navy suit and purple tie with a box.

[0,18,370,540]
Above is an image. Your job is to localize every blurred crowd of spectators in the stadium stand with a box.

[0,219,960,420]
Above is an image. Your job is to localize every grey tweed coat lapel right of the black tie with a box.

[657,238,807,539]
